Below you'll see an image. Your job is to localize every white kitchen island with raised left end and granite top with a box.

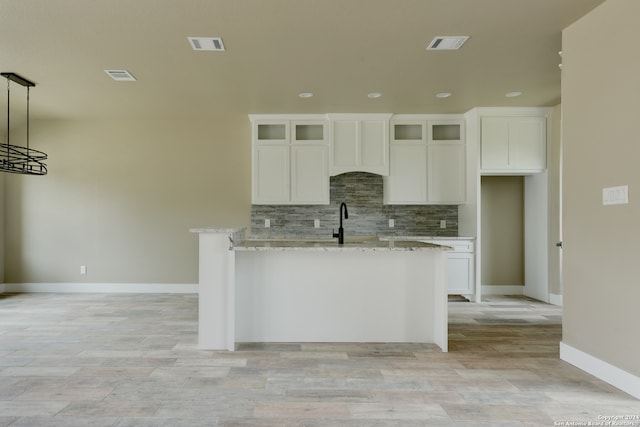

[192,229,448,351]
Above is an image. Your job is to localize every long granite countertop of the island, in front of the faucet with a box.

[231,239,452,252]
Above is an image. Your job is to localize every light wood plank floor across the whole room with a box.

[0,294,640,427]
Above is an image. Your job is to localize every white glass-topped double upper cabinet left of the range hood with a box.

[250,115,329,204]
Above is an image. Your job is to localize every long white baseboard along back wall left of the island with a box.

[0,283,198,294]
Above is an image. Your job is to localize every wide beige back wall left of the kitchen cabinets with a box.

[5,115,251,284]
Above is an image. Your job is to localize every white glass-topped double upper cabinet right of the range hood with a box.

[384,116,466,205]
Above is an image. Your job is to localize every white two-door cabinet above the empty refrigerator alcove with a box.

[480,116,547,175]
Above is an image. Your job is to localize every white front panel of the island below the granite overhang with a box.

[234,248,447,351]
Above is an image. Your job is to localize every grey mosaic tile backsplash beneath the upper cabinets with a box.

[251,172,458,238]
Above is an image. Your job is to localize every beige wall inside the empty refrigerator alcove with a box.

[480,176,524,286]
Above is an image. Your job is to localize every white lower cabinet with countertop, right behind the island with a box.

[422,239,475,296]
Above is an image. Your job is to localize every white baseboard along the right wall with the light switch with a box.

[560,342,640,399]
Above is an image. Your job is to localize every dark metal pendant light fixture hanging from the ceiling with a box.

[0,73,47,175]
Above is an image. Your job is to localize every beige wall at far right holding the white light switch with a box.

[562,0,640,376]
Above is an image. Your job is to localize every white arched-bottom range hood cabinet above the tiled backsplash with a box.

[328,114,391,176]
